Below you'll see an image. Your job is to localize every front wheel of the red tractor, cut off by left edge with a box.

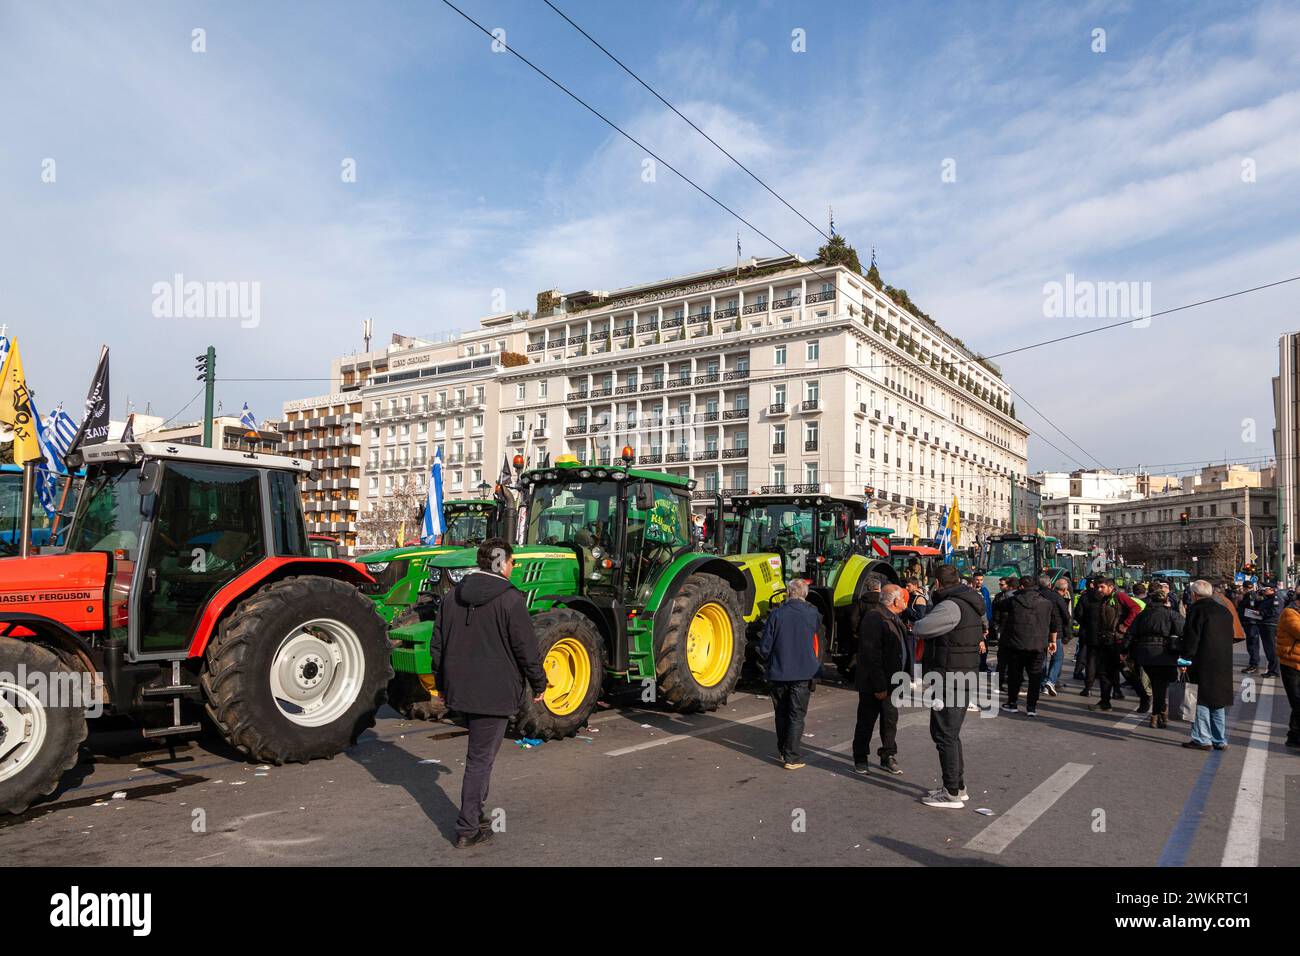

[0,637,88,813]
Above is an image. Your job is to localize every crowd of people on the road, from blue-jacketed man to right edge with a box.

[759,564,1300,809]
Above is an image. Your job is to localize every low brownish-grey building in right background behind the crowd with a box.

[1099,472,1277,581]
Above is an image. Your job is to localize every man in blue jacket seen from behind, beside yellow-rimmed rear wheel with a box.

[758,578,824,770]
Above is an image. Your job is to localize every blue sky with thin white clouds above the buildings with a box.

[0,0,1300,472]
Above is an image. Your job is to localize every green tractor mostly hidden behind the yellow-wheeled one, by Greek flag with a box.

[358,496,515,627]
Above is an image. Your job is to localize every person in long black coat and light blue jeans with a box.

[1178,581,1235,750]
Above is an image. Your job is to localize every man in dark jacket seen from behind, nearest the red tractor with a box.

[429,537,546,848]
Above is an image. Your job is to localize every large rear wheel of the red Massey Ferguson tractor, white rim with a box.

[202,575,393,765]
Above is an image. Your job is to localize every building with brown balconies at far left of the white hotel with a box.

[280,390,363,557]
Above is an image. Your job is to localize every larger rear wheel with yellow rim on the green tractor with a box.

[654,574,745,710]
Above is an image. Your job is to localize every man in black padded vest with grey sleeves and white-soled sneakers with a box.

[914,564,984,810]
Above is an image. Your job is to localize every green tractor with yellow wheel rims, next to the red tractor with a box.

[379,449,754,740]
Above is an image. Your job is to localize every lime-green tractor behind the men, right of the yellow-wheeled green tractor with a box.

[727,493,898,679]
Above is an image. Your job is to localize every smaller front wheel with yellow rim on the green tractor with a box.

[515,607,605,740]
